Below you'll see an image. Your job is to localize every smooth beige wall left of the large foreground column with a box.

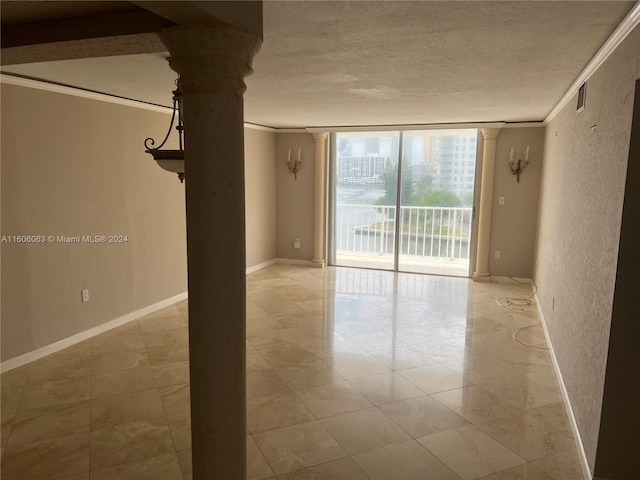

[1,84,187,360]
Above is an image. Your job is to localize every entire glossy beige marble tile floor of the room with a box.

[0,265,582,480]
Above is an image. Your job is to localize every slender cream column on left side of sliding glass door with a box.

[311,133,328,267]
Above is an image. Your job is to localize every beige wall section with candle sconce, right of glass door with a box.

[489,127,544,278]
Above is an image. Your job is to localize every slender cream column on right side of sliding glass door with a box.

[473,128,500,282]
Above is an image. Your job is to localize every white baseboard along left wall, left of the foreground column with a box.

[0,292,187,373]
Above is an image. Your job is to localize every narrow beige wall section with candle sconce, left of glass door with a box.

[276,133,315,260]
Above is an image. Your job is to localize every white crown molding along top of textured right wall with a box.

[544,1,640,126]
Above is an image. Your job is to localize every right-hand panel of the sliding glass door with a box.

[397,129,477,277]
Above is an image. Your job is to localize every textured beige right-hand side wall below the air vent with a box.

[534,28,640,471]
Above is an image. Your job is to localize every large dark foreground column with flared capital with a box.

[160,23,261,480]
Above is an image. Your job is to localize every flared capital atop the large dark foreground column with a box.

[160,23,262,96]
